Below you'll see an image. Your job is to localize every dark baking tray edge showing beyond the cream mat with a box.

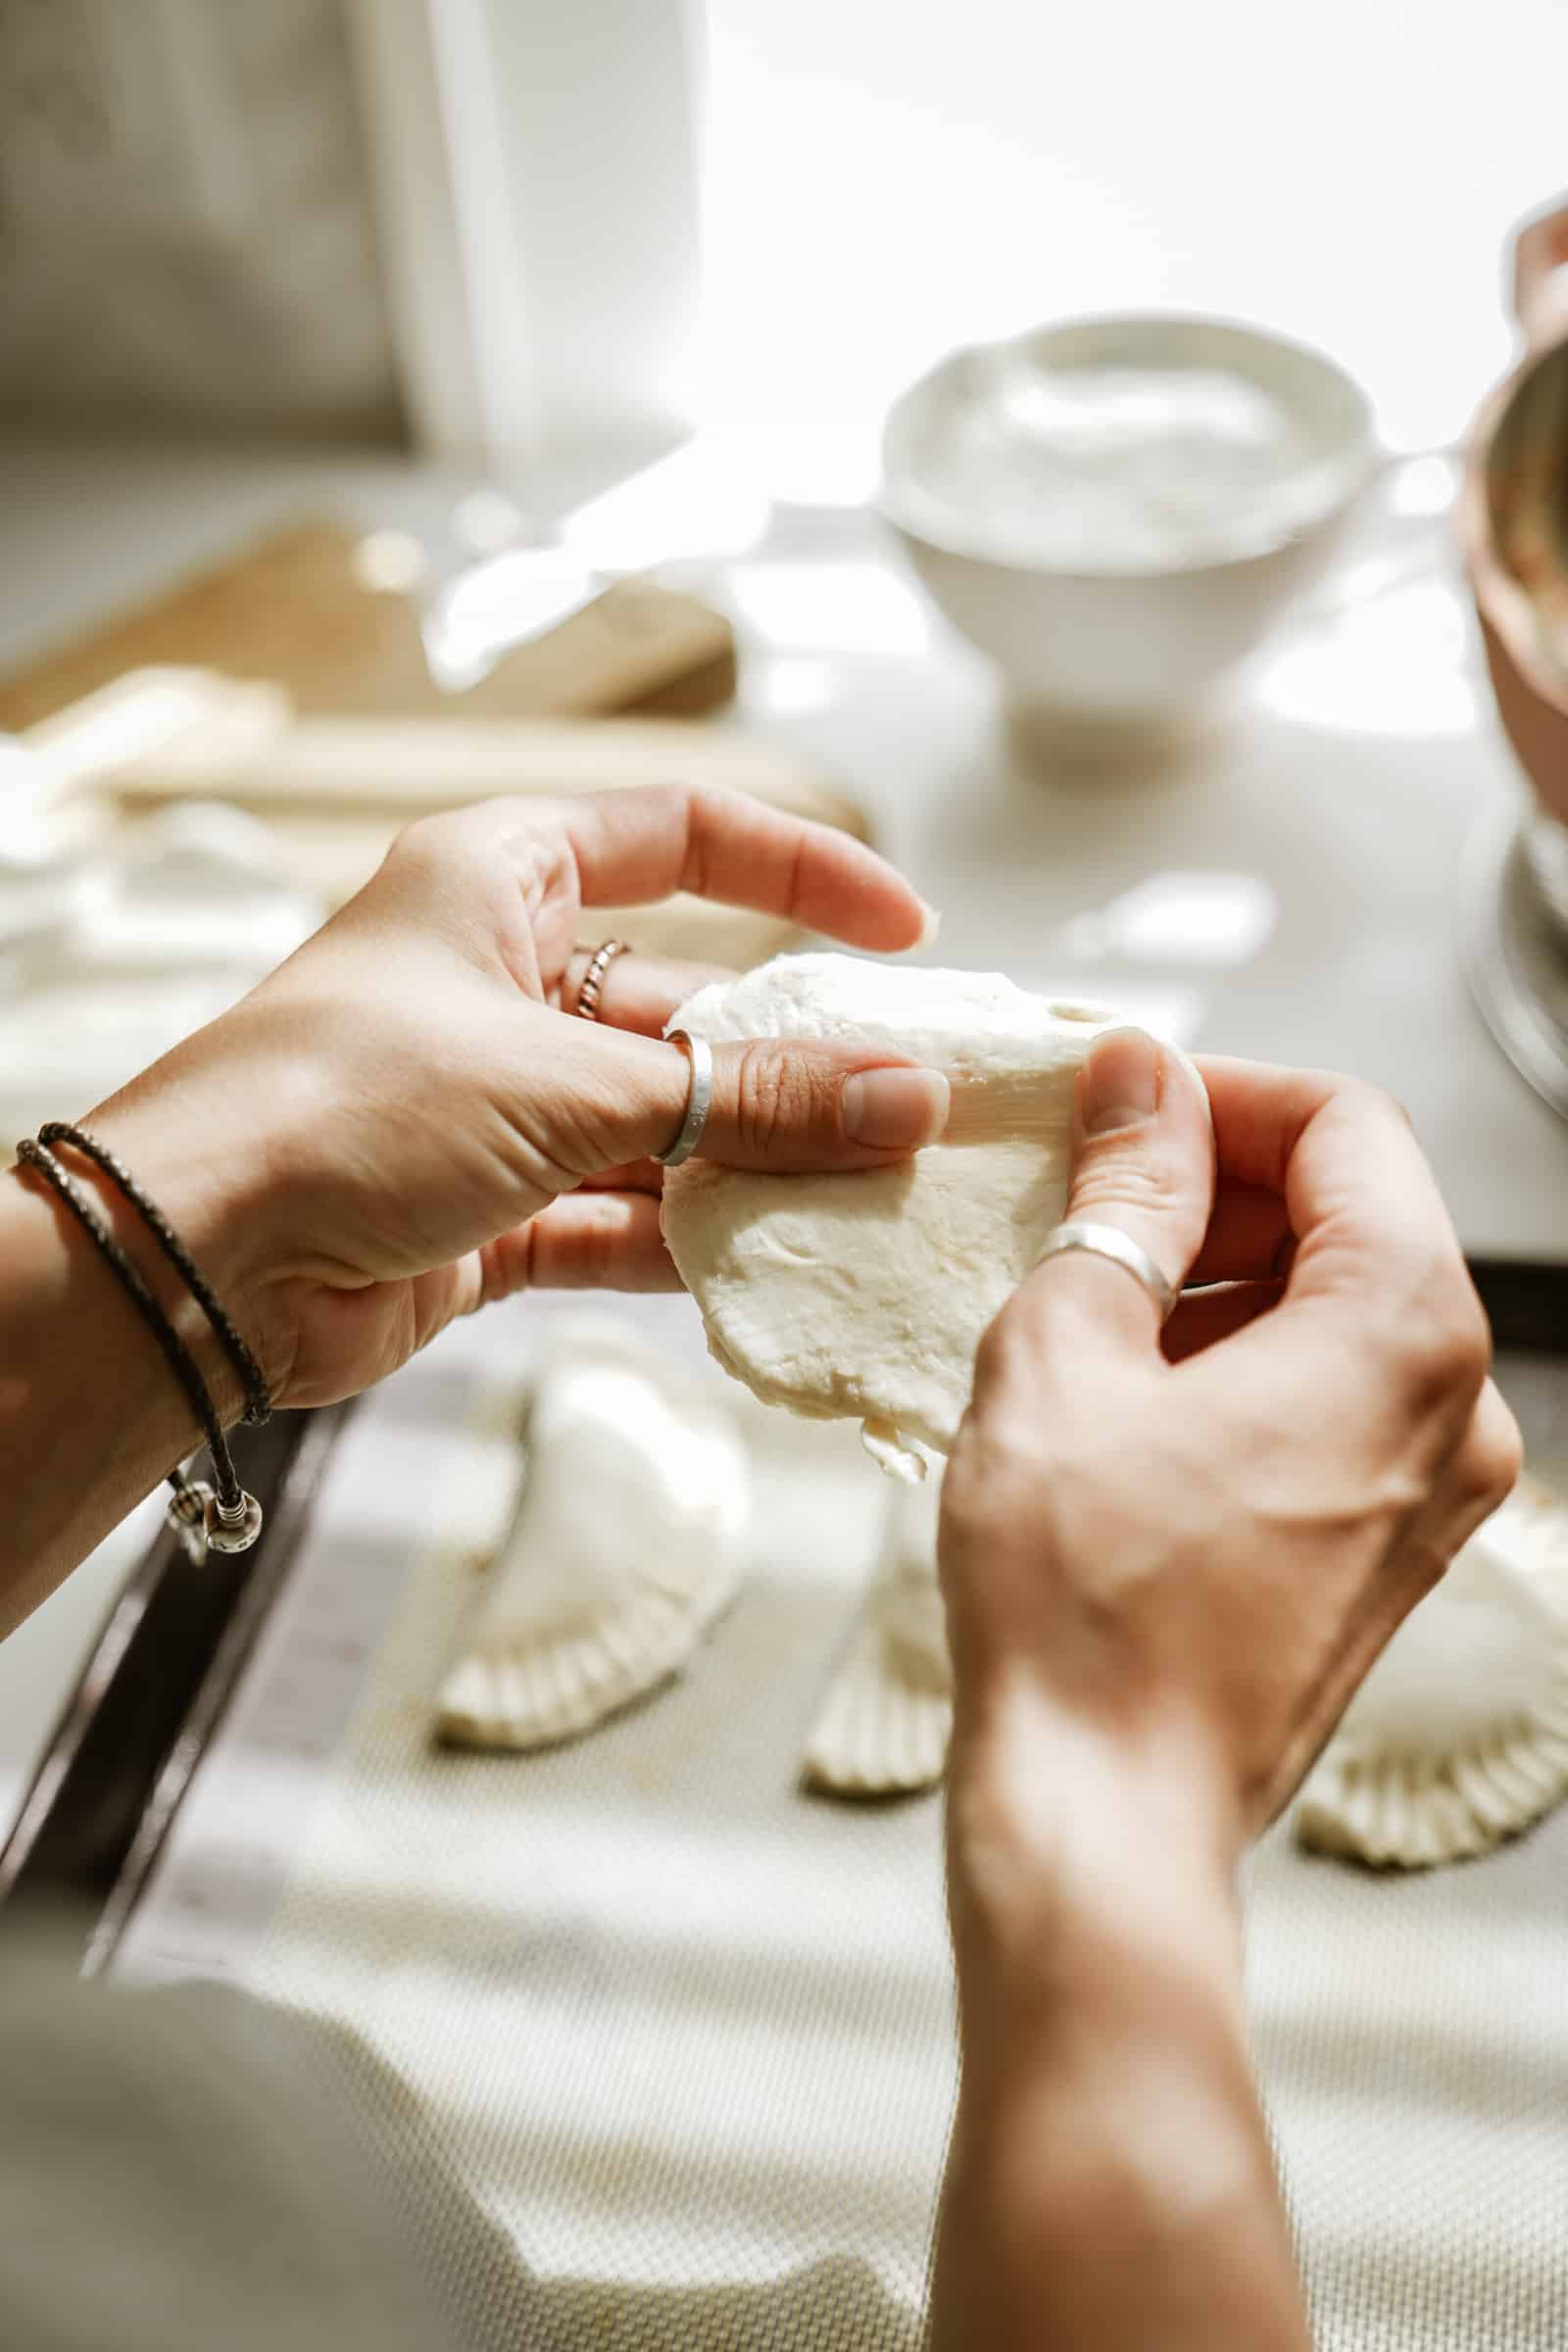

[0,1258,1568,1971]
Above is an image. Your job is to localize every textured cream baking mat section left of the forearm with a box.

[118,1300,955,2345]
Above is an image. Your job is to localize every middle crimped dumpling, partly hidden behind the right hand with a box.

[804,1477,953,1797]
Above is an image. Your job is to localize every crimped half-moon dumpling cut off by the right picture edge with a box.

[1296,1480,1568,1870]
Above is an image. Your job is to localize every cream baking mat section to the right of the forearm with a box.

[1246,1326,1568,2352]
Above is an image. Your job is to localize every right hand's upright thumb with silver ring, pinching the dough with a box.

[1025,1028,1215,1343]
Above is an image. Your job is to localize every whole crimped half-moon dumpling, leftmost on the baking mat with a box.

[437,1317,750,1747]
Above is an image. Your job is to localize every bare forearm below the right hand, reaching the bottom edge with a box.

[931,1702,1307,2352]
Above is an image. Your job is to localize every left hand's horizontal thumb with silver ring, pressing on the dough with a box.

[566,1033,950,1176]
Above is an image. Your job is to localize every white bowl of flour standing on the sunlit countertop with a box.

[879,316,1378,724]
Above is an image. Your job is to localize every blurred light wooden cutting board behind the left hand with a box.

[0,522,867,964]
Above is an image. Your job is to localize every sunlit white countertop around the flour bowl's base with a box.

[0,445,1568,1818]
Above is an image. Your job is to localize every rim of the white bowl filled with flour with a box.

[872,311,1382,583]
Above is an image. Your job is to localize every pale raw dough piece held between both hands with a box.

[662,955,1114,1480]
